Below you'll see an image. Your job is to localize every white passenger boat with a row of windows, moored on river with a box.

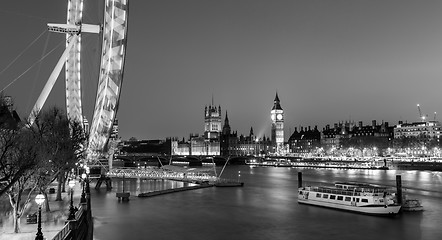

[298,182,401,216]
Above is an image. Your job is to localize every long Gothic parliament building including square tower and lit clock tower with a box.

[171,93,284,156]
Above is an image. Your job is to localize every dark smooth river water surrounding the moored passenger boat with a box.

[91,166,442,240]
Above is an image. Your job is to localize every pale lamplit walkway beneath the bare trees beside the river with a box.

[0,181,82,240]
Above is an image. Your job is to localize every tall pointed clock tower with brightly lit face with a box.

[270,93,284,153]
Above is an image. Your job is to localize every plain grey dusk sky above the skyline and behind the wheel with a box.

[0,0,442,140]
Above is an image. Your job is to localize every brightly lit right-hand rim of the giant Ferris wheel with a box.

[88,0,128,156]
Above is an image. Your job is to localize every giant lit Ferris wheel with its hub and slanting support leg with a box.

[28,0,128,159]
